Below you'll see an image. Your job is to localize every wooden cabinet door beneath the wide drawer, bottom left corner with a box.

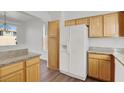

[0,70,25,82]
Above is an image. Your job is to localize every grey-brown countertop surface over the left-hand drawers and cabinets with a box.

[0,52,40,67]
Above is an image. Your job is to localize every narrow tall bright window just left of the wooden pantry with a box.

[43,24,48,51]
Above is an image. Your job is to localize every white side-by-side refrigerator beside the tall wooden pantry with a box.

[60,25,88,80]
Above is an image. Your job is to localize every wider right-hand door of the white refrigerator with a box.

[69,25,88,77]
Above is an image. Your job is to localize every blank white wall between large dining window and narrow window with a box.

[26,19,43,54]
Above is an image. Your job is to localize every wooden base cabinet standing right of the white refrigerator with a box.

[88,53,114,81]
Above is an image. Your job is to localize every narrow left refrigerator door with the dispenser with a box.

[60,27,70,72]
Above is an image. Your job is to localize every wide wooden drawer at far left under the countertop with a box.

[0,62,24,77]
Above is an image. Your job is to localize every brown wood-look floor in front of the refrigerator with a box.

[41,60,99,82]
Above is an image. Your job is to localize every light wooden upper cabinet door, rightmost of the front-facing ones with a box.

[104,13,119,37]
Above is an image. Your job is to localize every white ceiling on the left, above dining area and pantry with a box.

[0,11,61,22]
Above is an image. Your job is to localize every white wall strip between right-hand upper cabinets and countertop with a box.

[89,37,124,48]
